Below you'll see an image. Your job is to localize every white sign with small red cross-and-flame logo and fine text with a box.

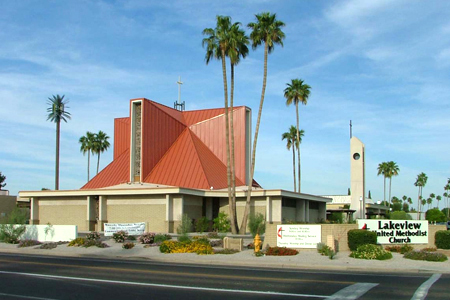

[277,225,322,248]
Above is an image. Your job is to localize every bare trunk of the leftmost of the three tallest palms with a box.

[221,49,236,234]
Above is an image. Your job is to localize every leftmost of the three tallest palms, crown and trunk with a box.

[202,16,241,233]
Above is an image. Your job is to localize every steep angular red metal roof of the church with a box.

[82,98,249,189]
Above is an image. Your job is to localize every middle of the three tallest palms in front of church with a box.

[226,22,250,231]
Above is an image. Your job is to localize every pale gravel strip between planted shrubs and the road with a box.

[0,240,450,273]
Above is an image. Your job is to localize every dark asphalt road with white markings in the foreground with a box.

[0,254,450,300]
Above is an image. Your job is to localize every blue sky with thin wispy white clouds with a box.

[0,0,450,208]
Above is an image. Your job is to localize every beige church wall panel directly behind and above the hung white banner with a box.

[106,196,167,232]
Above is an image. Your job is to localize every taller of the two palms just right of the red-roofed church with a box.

[284,79,311,193]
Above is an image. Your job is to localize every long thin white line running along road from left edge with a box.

[0,271,326,300]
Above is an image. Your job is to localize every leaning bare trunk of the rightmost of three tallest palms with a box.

[239,42,269,234]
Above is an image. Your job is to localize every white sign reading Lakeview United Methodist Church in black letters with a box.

[358,219,428,244]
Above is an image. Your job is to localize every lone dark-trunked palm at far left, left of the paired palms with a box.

[47,95,70,190]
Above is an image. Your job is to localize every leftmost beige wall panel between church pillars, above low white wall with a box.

[39,197,88,231]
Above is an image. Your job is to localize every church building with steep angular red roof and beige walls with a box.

[19,98,331,233]
